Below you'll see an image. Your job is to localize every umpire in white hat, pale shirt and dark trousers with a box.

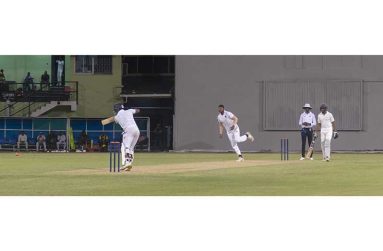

[299,104,317,160]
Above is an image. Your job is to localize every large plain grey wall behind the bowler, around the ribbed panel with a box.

[174,56,383,151]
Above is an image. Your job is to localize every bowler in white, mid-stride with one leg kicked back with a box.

[217,105,254,161]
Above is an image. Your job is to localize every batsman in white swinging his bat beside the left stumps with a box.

[101,104,140,171]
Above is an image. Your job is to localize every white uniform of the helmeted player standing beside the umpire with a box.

[318,112,335,159]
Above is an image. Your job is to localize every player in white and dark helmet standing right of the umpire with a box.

[317,104,338,162]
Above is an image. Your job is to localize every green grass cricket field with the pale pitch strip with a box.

[0,153,383,195]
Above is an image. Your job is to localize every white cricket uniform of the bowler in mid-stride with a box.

[217,111,247,155]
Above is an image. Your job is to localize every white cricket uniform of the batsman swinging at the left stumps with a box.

[114,109,140,166]
